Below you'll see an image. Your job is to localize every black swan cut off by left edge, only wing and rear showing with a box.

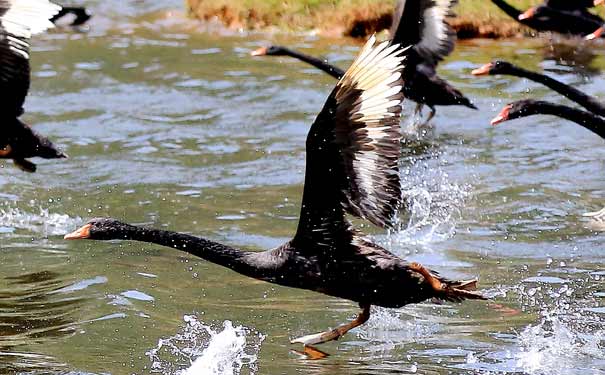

[0,0,66,172]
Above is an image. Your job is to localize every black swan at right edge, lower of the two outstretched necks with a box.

[491,99,605,221]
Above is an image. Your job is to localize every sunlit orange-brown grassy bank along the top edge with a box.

[186,0,544,38]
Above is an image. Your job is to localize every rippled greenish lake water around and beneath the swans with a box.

[0,0,605,375]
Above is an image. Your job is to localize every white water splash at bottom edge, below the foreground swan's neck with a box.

[146,315,265,375]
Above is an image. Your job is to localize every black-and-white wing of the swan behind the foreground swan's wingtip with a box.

[391,0,458,65]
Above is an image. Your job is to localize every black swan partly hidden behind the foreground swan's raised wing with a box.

[252,0,477,122]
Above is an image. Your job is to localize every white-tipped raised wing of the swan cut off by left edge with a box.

[0,0,61,118]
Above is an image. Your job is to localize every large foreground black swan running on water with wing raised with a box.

[65,37,483,346]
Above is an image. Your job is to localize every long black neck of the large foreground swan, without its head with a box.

[126,226,275,279]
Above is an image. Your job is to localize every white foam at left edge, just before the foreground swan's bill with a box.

[0,207,83,236]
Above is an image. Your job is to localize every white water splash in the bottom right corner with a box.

[457,275,605,375]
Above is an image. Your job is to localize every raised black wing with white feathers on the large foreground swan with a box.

[294,37,403,251]
